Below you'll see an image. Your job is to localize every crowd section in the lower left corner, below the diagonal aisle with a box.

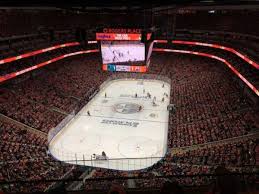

[0,122,78,192]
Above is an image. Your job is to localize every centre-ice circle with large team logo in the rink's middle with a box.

[113,102,143,114]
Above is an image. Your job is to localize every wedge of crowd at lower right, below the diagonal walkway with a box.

[173,139,256,167]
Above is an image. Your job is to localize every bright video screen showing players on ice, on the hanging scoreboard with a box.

[101,41,145,64]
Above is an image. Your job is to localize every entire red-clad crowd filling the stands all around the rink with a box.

[0,39,259,191]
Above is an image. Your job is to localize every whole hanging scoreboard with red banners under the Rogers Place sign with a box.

[96,28,152,72]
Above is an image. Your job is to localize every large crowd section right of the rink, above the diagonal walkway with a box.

[152,54,258,147]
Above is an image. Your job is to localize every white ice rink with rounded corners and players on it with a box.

[49,79,170,170]
